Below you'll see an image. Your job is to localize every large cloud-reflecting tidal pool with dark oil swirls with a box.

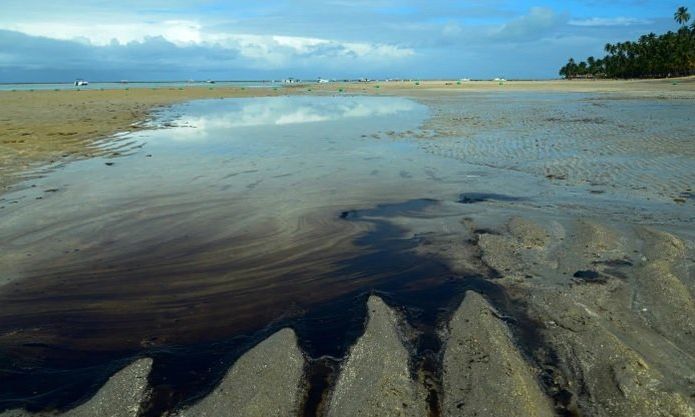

[0,97,484,416]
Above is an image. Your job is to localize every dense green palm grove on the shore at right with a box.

[560,7,695,79]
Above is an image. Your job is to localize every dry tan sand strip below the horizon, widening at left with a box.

[0,77,695,193]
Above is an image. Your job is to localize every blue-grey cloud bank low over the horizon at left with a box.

[0,30,414,82]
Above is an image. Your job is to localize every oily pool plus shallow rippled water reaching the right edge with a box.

[0,94,692,416]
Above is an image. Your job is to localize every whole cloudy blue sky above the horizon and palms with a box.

[0,0,695,83]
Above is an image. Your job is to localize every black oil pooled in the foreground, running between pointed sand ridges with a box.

[0,200,569,417]
